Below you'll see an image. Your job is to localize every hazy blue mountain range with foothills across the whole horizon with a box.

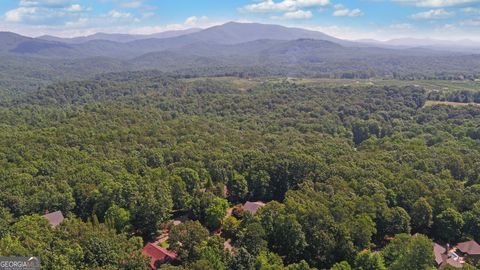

[0,22,480,87]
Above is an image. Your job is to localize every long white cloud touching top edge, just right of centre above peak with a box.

[240,0,330,12]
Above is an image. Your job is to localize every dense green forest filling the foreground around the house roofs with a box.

[0,72,480,270]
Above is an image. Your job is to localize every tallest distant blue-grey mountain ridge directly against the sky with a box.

[0,22,355,59]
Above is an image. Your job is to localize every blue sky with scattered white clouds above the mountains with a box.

[0,0,480,41]
